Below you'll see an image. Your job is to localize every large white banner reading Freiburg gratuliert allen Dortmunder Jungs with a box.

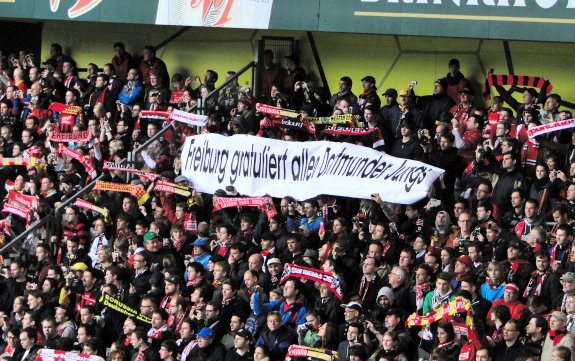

[182,134,444,204]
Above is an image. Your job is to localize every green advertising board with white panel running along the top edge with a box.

[0,0,575,42]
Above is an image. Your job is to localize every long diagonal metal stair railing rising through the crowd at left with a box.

[0,61,256,255]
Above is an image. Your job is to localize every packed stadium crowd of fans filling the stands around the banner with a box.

[0,43,575,361]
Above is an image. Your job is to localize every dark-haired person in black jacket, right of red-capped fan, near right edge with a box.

[523,250,561,311]
